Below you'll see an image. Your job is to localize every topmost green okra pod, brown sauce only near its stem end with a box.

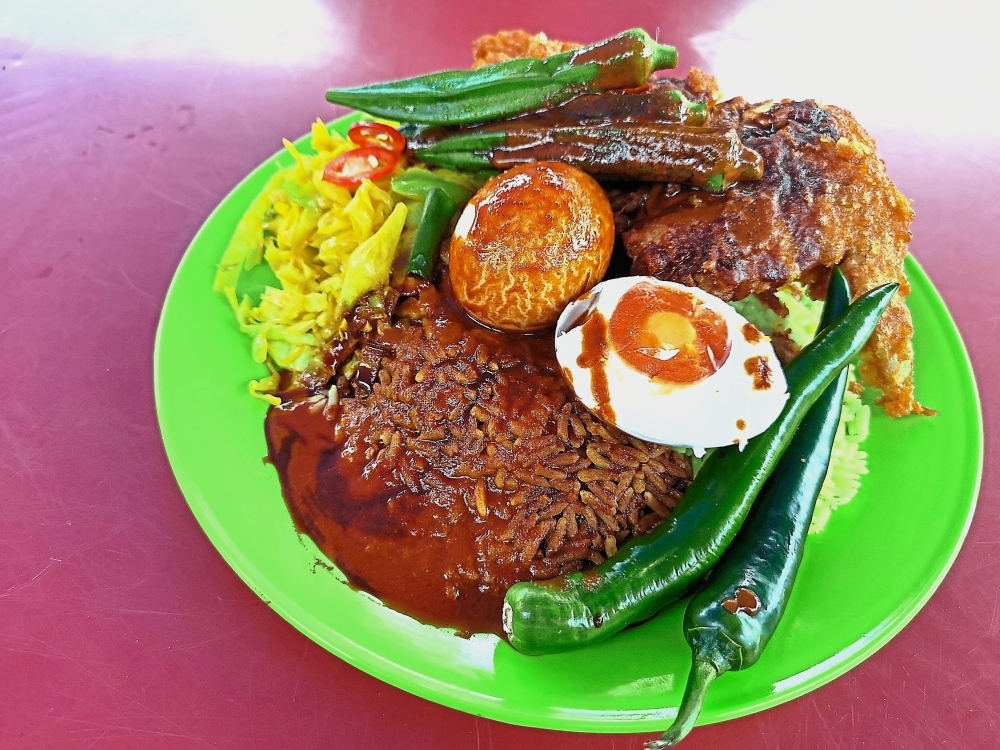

[326,29,677,125]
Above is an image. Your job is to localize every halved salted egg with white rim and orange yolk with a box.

[555,276,788,455]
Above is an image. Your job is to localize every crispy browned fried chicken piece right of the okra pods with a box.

[612,99,933,416]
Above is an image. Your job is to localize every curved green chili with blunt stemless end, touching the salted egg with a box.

[503,284,899,654]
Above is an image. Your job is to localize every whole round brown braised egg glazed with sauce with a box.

[449,162,615,332]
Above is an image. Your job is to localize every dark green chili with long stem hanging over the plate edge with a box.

[646,268,851,750]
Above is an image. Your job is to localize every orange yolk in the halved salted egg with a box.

[609,282,730,385]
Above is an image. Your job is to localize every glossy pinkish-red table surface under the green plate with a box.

[0,0,1000,750]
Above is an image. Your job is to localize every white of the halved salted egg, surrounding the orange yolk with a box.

[555,276,788,455]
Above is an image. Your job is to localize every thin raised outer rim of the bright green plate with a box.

[152,119,985,733]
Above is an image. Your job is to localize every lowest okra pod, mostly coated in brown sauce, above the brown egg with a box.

[414,121,764,193]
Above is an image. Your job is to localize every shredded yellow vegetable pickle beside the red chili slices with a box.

[213,120,406,403]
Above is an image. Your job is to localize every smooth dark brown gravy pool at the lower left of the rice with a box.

[266,402,503,633]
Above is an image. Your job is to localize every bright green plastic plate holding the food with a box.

[154,119,983,732]
